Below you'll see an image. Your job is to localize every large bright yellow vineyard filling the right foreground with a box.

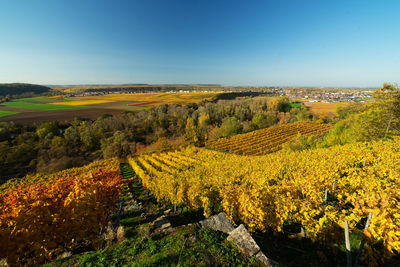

[129,139,400,266]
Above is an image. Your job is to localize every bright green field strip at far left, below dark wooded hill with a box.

[0,97,87,110]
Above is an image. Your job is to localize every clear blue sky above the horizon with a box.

[0,0,400,86]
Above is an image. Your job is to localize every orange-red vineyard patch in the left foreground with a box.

[0,159,122,265]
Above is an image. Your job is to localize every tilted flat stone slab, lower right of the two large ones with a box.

[227,224,260,257]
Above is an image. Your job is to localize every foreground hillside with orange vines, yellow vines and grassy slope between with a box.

[0,138,400,266]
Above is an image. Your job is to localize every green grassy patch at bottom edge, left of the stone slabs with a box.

[47,221,253,266]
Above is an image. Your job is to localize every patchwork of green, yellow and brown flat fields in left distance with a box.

[0,93,217,124]
